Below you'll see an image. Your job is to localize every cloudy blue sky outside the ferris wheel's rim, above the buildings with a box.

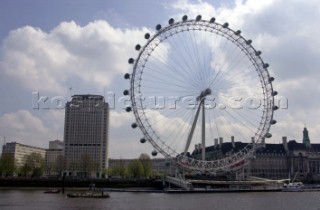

[0,0,320,158]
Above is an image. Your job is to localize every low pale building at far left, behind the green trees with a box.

[2,142,46,168]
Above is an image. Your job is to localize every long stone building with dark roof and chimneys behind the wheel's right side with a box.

[191,128,320,182]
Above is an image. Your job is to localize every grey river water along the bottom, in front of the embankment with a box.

[0,190,320,210]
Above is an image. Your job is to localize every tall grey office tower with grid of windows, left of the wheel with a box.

[64,95,109,177]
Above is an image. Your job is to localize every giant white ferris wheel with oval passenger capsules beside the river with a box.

[124,15,278,171]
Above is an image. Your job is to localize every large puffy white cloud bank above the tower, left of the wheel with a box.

[0,20,147,94]
